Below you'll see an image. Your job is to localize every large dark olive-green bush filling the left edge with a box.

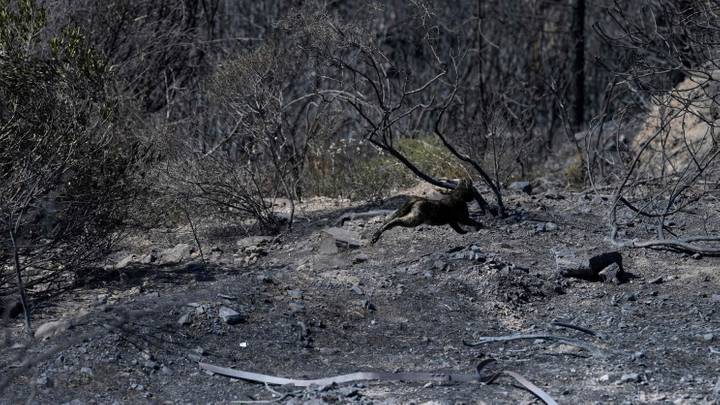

[0,0,139,290]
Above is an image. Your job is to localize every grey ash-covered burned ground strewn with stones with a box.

[0,183,720,404]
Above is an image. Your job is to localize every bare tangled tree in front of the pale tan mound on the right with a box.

[586,1,720,255]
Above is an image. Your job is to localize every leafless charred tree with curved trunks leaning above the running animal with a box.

[290,7,505,215]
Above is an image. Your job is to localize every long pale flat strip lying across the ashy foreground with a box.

[198,359,557,405]
